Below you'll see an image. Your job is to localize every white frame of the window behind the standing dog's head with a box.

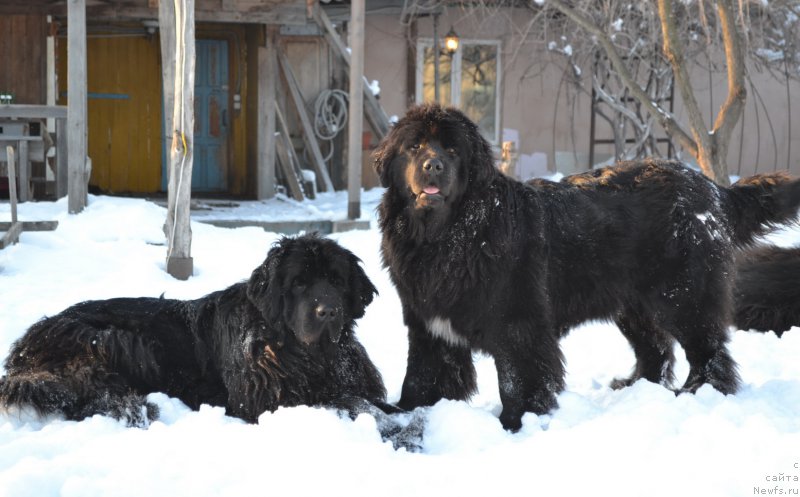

[414,38,503,146]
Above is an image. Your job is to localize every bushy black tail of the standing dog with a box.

[726,172,800,246]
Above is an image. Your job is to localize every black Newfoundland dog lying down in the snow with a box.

[0,236,390,425]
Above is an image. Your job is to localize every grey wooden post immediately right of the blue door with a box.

[256,25,279,200]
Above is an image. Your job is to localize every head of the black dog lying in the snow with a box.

[247,235,378,345]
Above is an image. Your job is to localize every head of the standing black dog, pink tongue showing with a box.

[373,104,497,212]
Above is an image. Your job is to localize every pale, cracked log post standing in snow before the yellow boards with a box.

[158,0,195,280]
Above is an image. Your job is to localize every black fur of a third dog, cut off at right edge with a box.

[733,246,800,336]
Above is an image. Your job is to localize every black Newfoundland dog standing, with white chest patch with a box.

[374,101,800,430]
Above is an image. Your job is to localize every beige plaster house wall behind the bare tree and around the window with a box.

[365,10,800,175]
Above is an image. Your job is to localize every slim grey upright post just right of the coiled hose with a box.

[347,0,365,219]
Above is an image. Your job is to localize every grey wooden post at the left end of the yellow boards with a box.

[67,0,88,214]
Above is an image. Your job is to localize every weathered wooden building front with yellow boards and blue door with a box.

[0,0,387,198]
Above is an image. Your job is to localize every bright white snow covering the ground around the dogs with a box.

[0,190,800,497]
